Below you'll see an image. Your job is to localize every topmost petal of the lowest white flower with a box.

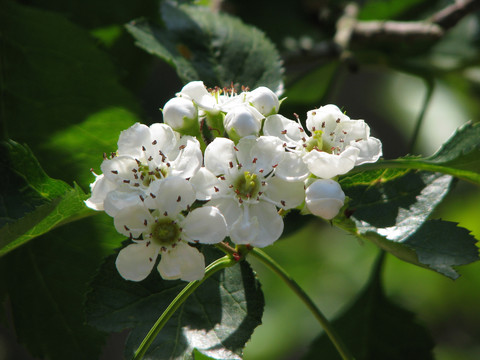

[145,176,195,217]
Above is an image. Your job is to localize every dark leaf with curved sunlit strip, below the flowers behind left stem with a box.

[87,248,264,360]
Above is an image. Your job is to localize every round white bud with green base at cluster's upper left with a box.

[163,97,199,136]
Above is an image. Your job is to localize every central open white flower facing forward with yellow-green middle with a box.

[190,136,308,247]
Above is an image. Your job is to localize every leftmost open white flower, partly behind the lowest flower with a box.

[86,123,202,216]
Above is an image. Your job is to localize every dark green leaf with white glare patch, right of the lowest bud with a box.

[334,169,478,279]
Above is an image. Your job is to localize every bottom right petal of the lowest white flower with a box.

[157,242,205,281]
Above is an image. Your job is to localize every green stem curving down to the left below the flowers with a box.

[133,256,237,360]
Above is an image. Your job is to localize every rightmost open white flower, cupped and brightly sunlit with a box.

[263,105,382,179]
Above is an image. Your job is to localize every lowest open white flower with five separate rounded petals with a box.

[114,176,227,281]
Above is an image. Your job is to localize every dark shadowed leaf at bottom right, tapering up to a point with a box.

[303,253,434,360]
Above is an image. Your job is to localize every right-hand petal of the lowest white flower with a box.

[181,206,227,244]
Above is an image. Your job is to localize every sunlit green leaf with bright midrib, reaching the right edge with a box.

[355,122,480,185]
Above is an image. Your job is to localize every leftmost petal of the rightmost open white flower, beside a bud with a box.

[263,114,305,147]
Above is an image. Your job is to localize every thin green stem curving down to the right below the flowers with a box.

[249,248,354,360]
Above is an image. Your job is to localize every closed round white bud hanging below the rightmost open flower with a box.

[305,179,345,220]
